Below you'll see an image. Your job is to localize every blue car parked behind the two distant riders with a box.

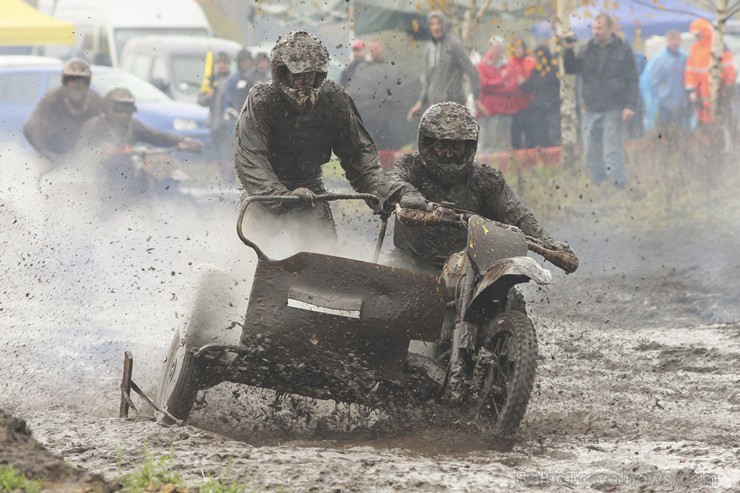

[0,56,211,148]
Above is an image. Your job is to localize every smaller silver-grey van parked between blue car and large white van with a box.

[121,35,241,103]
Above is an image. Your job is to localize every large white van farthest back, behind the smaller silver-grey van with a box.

[38,0,213,67]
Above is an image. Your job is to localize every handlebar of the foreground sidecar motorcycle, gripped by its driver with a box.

[396,205,578,274]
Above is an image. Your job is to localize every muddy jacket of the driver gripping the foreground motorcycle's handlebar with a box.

[389,152,549,267]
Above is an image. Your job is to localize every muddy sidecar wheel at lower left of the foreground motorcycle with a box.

[157,335,203,424]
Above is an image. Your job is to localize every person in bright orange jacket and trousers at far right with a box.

[684,18,736,124]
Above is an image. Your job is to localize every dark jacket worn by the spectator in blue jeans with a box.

[563,36,639,112]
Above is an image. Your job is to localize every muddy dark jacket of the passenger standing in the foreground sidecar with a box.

[235,81,407,213]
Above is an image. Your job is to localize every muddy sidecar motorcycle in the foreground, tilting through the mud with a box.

[150,194,577,433]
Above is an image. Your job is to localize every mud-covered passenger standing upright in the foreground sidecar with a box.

[235,31,423,252]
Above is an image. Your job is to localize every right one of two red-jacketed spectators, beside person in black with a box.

[509,38,537,149]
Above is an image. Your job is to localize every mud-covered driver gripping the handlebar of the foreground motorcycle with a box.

[389,102,572,400]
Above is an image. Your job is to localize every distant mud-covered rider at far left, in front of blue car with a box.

[23,58,103,164]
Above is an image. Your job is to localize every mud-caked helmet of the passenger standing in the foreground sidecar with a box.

[270,31,329,111]
